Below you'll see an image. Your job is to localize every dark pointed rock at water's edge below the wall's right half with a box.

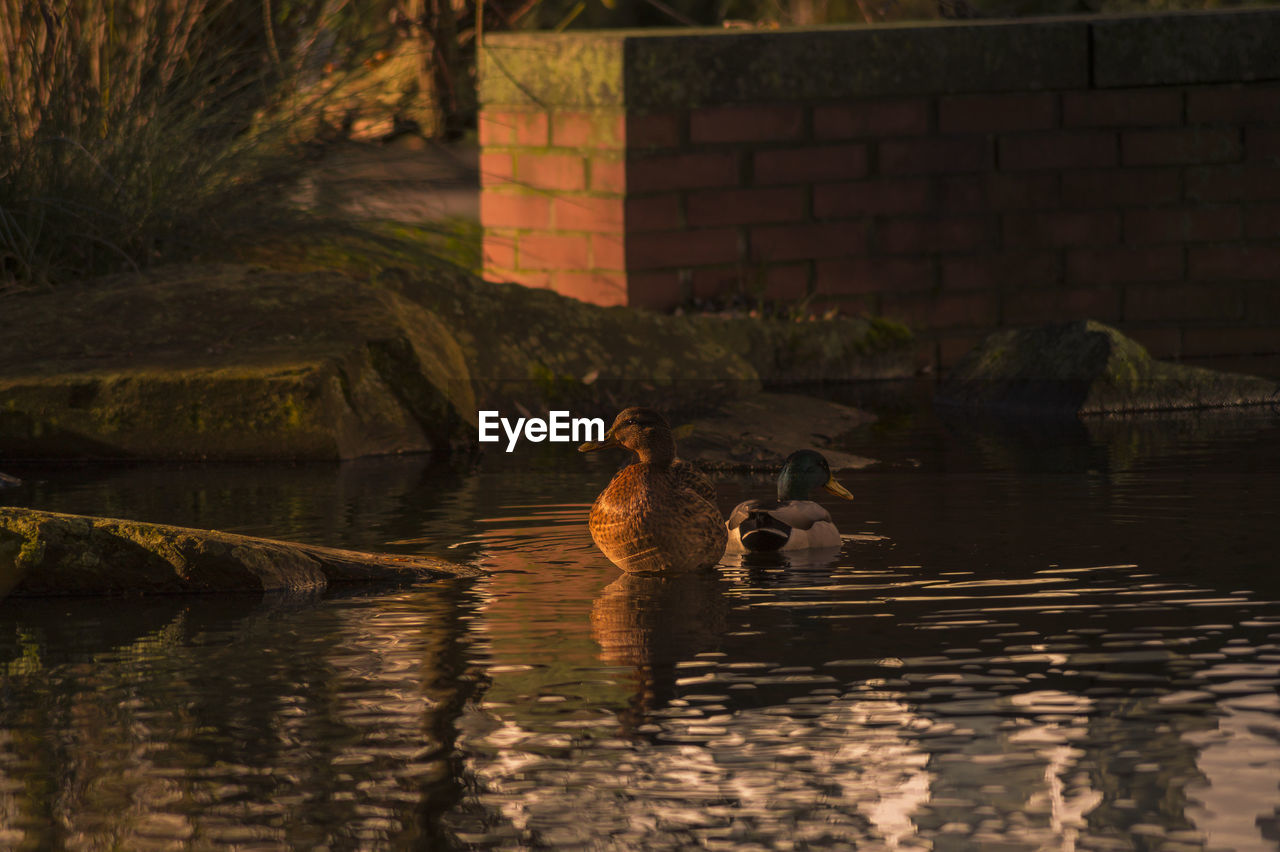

[934,320,1280,416]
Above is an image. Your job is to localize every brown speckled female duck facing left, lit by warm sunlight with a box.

[577,408,728,572]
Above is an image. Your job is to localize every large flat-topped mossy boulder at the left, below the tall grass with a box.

[0,265,475,458]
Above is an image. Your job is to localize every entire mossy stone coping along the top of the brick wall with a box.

[480,9,1280,113]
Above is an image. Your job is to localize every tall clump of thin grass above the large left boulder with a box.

[0,0,337,293]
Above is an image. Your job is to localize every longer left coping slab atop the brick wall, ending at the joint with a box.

[480,18,1089,111]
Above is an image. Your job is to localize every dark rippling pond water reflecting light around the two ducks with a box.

[0,388,1280,852]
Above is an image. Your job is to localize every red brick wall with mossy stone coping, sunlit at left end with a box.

[480,12,1280,365]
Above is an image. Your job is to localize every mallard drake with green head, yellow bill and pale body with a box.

[726,450,854,551]
